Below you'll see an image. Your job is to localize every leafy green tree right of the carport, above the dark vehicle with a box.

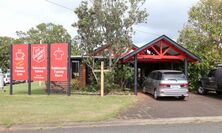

[178,0,222,89]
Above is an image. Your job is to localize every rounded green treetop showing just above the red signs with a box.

[16,23,79,55]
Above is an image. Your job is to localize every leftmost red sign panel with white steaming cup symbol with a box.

[12,44,28,80]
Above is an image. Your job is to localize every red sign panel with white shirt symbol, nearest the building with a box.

[50,43,68,81]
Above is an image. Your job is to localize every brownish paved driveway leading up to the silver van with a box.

[118,93,222,119]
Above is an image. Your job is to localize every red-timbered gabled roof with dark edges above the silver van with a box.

[121,35,200,63]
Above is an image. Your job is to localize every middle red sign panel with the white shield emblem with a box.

[31,44,48,81]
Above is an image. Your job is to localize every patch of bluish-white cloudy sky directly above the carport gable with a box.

[133,0,198,45]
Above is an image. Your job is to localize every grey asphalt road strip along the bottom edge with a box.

[1,123,222,133]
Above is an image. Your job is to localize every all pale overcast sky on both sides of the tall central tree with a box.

[0,0,198,46]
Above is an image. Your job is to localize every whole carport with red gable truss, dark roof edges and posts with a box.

[121,35,200,95]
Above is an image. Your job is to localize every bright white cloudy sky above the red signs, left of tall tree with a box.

[0,0,80,37]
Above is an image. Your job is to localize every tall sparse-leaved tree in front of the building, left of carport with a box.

[73,0,148,82]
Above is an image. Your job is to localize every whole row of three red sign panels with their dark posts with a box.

[10,43,68,96]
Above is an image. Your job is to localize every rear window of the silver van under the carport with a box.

[163,72,185,80]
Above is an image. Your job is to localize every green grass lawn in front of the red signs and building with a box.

[0,82,136,127]
